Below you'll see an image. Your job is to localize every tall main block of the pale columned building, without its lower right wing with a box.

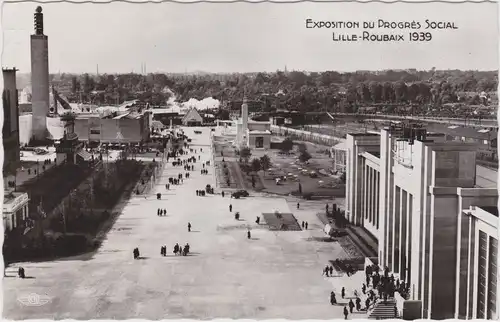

[346,126,498,319]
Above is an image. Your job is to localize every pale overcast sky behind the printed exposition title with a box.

[2,3,498,73]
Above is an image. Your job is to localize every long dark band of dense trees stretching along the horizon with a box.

[48,70,498,111]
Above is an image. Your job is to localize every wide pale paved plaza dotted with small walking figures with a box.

[3,128,365,320]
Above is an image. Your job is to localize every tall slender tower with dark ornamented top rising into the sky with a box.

[31,6,50,140]
